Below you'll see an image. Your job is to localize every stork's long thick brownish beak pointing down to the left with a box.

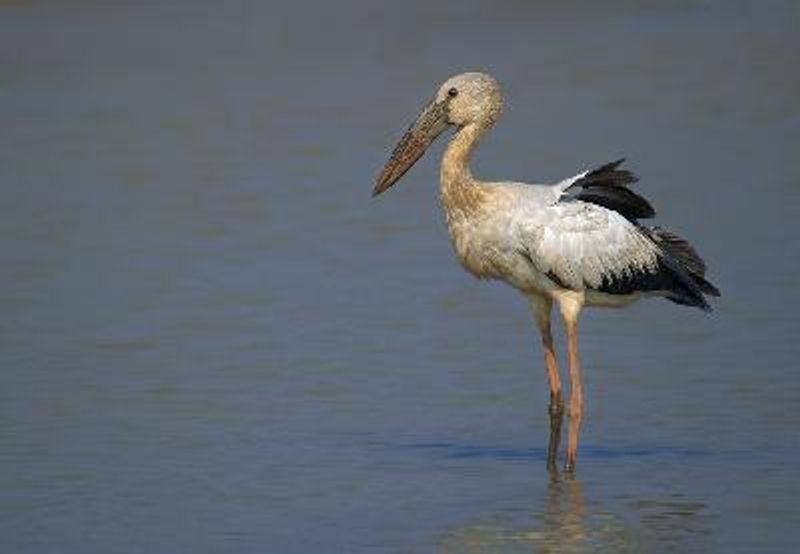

[372,100,448,196]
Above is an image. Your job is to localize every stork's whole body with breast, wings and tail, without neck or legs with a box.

[448,161,719,309]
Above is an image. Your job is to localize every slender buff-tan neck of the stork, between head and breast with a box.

[440,123,485,216]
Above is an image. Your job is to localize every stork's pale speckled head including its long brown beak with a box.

[372,72,503,196]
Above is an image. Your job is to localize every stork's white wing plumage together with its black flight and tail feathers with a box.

[514,160,719,310]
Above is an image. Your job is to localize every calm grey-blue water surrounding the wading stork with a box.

[0,0,800,553]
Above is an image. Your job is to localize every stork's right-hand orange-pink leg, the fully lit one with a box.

[559,296,583,471]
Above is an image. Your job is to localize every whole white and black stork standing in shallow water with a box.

[373,73,719,471]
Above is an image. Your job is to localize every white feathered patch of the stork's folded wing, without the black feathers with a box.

[518,200,661,294]
